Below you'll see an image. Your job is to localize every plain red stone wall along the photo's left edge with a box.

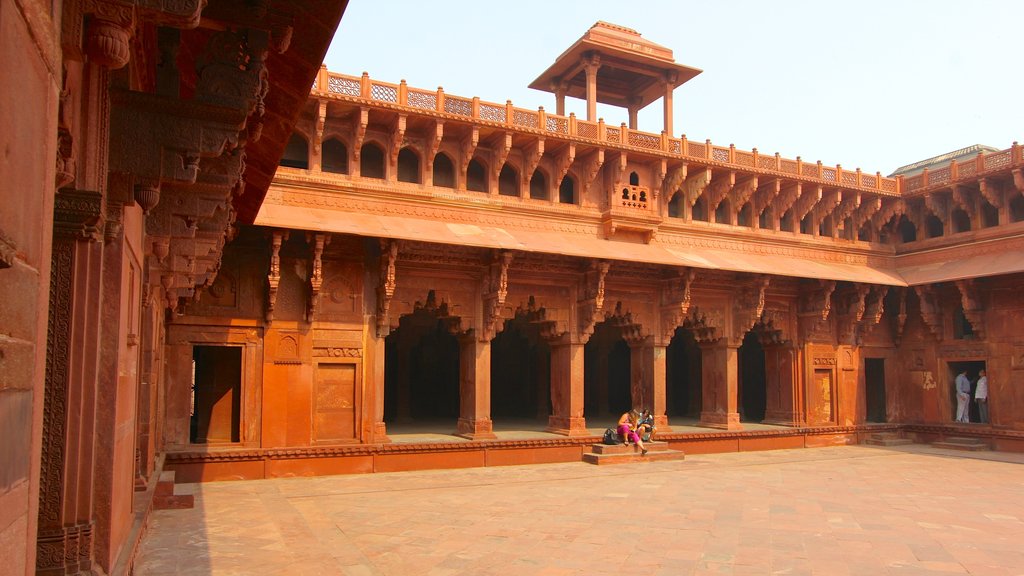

[0,0,59,574]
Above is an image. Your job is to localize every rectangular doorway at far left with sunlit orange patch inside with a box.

[188,346,242,444]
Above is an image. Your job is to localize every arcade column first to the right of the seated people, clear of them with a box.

[700,338,743,430]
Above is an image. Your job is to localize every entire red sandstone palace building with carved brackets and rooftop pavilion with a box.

[0,7,1024,574]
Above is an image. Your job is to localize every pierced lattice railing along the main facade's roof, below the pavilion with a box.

[312,69,901,196]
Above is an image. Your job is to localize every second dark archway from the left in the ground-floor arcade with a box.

[490,318,551,422]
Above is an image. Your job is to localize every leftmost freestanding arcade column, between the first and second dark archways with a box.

[458,335,498,440]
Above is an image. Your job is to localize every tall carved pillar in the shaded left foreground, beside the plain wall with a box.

[36,190,102,575]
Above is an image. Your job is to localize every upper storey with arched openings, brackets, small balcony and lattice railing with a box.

[270,68,1024,249]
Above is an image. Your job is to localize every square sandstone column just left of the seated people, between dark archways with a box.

[548,339,588,436]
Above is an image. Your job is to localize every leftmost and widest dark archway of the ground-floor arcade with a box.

[384,308,459,422]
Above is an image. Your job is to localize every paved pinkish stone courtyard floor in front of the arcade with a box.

[135,445,1024,576]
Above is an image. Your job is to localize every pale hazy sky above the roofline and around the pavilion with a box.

[326,0,1024,174]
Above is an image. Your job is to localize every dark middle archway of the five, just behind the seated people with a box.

[584,322,633,420]
